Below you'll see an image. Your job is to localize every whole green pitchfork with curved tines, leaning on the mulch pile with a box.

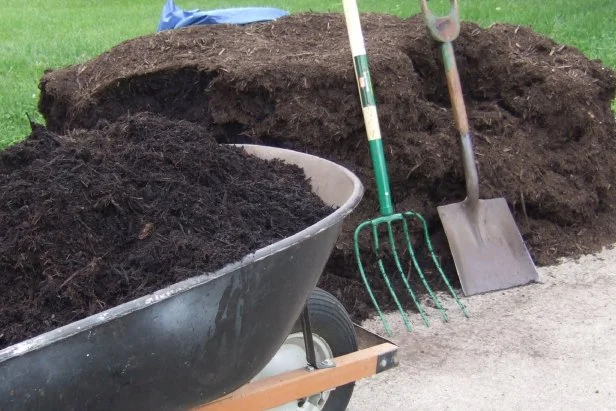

[342,0,468,336]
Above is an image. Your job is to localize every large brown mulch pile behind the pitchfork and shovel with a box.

[39,14,616,318]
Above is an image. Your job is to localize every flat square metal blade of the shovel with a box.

[437,198,538,296]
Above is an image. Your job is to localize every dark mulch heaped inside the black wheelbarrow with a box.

[0,114,332,349]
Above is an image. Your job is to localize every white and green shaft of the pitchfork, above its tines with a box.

[342,0,394,216]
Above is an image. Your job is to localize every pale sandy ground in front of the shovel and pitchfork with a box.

[349,249,616,411]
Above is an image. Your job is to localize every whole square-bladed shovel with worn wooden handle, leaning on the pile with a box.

[420,0,538,296]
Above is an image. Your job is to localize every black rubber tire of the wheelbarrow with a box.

[293,288,357,411]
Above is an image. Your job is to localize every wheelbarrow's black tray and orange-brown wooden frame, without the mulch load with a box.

[0,145,397,411]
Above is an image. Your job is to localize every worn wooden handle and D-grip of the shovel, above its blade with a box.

[421,0,479,207]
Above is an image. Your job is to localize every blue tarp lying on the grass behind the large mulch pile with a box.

[156,0,289,31]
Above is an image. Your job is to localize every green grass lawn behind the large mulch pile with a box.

[0,0,616,148]
